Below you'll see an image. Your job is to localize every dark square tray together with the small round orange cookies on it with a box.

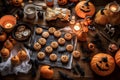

[31,25,76,69]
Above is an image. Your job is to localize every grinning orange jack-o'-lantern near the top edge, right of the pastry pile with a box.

[75,1,95,18]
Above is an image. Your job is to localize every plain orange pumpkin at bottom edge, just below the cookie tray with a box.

[40,65,54,79]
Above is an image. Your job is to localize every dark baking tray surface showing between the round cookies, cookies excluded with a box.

[26,25,77,69]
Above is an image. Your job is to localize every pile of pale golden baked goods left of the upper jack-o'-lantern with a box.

[46,8,70,21]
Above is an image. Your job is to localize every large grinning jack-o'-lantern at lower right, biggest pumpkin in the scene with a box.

[90,53,115,76]
